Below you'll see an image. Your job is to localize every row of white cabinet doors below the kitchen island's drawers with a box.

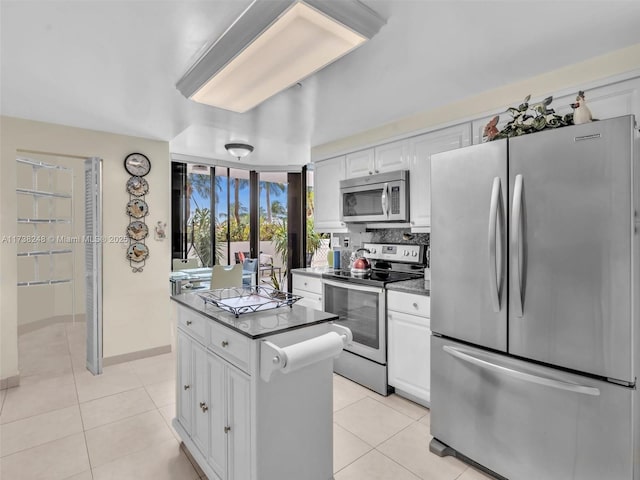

[176,329,251,480]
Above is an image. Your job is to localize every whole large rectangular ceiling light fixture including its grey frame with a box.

[176,0,385,113]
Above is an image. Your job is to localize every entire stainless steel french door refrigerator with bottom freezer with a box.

[430,116,640,480]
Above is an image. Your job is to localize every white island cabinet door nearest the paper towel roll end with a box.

[227,367,251,480]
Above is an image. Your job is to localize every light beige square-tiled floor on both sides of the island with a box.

[0,323,489,480]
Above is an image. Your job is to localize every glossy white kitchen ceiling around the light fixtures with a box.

[0,0,640,165]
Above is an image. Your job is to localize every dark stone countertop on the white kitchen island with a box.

[171,292,338,339]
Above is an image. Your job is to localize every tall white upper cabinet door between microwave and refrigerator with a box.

[409,123,471,229]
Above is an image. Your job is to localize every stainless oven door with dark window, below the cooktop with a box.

[322,280,387,365]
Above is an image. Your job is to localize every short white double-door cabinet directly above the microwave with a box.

[346,140,409,178]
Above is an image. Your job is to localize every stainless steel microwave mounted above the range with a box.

[340,170,409,222]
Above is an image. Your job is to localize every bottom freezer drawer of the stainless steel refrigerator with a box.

[431,337,640,480]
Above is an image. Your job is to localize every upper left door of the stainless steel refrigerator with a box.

[431,140,507,351]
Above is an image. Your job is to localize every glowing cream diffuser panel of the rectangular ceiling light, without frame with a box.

[191,2,367,113]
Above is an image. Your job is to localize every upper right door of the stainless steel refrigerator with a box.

[509,116,634,382]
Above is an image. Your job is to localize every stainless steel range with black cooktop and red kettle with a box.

[322,243,426,396]
